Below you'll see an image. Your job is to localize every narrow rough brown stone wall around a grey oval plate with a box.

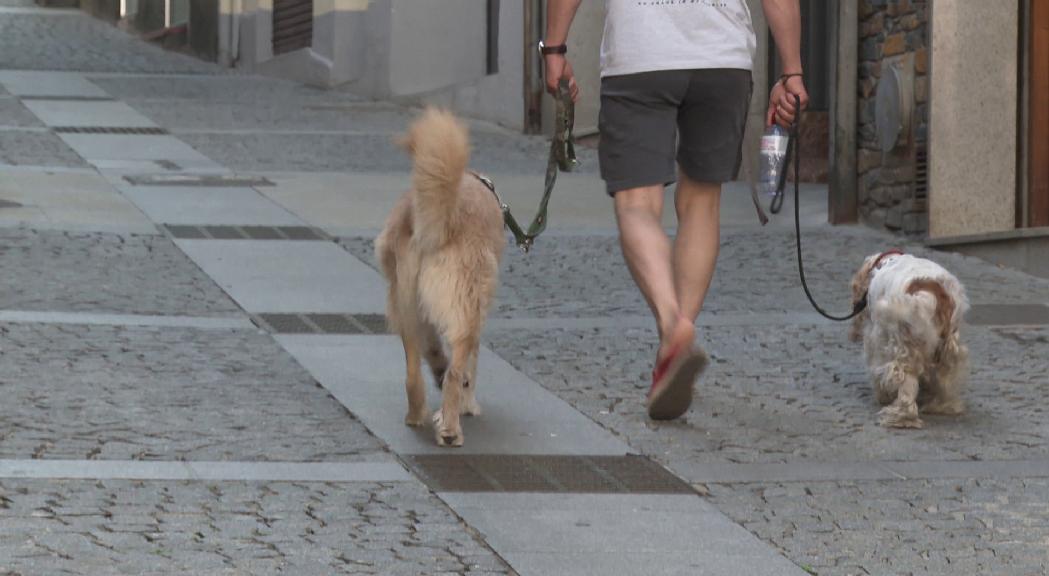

[857,0,929,234]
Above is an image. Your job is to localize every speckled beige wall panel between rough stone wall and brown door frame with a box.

[928,0,1020,238]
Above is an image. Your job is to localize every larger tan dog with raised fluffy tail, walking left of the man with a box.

[376,109,506,446]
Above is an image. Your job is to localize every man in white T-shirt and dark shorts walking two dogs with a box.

[539,0,809,420]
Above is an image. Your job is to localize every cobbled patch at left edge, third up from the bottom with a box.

[0,229,240,317]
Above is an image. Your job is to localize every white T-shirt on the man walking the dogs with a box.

[601,0,757,78]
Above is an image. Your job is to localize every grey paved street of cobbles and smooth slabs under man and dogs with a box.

[0,0,1049,575]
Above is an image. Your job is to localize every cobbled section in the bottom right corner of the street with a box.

[709,478,1049,576]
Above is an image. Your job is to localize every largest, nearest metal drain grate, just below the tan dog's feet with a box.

[406,454,694,494]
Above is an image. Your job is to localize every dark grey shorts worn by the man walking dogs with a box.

[598,68,753,195]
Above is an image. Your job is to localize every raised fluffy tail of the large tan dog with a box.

[401,108,470,250]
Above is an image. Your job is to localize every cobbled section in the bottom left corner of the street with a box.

[0,481,513,576]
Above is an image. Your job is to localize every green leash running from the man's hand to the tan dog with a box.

[473,79,579,253]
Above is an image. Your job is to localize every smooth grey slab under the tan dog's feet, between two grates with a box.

[277,336,630,455]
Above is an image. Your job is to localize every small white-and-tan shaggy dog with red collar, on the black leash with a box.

[850,250,969,428]
